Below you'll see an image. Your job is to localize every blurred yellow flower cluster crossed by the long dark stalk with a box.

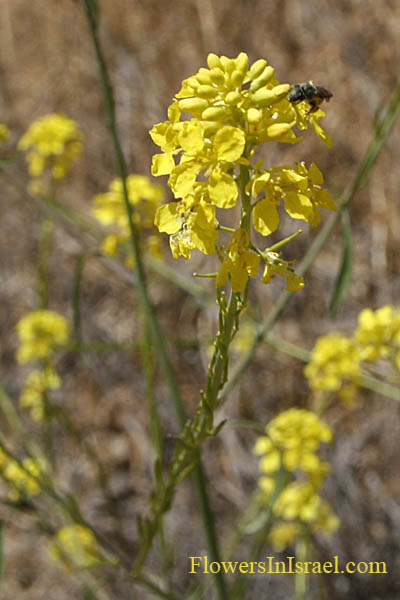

[93,175,164,258]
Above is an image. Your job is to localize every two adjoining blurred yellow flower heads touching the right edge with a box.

[304,305,400,400]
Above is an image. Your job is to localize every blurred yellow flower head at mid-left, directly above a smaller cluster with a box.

[17,310,69,363]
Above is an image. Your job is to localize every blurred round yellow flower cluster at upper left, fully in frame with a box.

[18,113,82,179]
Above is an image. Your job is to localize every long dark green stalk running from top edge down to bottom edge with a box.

[83,0,227,600]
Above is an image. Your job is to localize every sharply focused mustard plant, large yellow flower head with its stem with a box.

[137,52,336,569]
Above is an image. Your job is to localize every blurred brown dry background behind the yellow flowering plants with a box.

[0,0,400,600]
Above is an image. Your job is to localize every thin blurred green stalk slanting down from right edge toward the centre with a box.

[220,74,400,400]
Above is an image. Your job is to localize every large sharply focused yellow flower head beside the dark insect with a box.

[150,52,336,292]
